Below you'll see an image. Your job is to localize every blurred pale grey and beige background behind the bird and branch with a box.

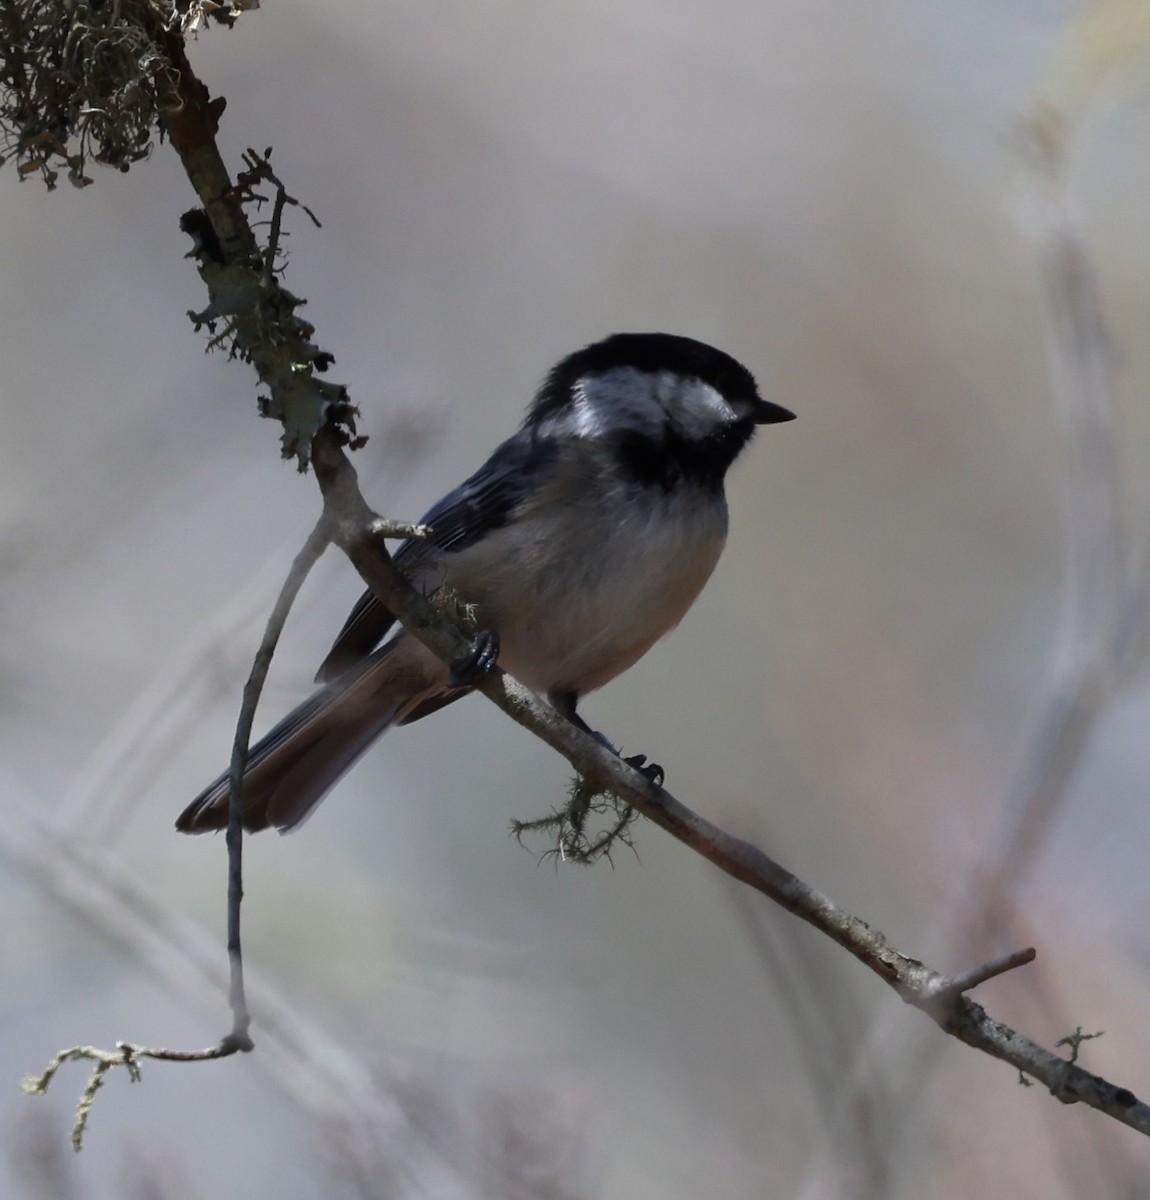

[0,0,1150,1200]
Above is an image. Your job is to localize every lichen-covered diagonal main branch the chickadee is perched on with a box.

[144,21,1150,1134]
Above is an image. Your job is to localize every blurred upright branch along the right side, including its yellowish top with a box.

[971,11,1150,936]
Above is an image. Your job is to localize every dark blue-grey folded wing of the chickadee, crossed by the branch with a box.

[316,430,556,683]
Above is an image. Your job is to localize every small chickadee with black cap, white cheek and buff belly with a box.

[176,334,793,833]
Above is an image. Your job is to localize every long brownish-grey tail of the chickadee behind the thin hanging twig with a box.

[175,638,455,833]
